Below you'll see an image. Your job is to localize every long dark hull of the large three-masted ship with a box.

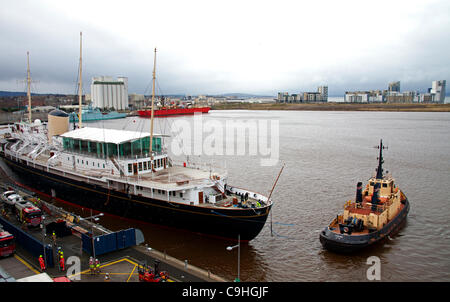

[2,156,271,241]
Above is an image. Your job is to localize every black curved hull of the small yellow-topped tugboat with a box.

[320,199,409,254]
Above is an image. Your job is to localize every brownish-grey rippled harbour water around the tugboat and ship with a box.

[65,111,450,281]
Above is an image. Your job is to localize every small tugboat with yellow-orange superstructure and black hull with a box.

[320,140,409,253]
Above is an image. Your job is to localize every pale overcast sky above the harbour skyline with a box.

[0,0,450,96]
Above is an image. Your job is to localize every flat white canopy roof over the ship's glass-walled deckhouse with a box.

[61,127,165,145]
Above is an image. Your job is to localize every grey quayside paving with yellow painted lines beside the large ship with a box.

[0,180,227,282]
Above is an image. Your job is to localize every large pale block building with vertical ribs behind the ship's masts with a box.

[91,76,128,110]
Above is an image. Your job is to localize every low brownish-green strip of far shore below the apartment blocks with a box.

[211,102,450,112]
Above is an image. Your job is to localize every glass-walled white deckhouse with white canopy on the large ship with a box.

[61,127,168,175]
